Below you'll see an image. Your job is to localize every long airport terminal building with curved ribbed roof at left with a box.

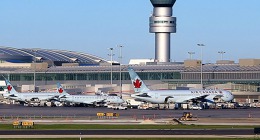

[0,47,260,103]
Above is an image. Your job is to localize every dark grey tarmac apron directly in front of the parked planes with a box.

[0,104,260,119]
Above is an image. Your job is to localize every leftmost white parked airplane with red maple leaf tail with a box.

[4,79,60,103]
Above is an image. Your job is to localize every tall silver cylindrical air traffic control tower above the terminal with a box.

[150,0,176,62]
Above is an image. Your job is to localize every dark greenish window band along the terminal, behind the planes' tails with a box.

[2,72,181,81]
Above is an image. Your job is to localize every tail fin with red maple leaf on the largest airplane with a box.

[128,68,149,92]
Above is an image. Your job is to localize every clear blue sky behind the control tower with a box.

[0,0,260,63]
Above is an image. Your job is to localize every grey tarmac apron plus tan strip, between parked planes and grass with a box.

[0,104,260,125]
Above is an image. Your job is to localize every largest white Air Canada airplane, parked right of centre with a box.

[128,68,234,104]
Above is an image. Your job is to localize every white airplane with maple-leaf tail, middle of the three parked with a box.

[57,83,124,105]
